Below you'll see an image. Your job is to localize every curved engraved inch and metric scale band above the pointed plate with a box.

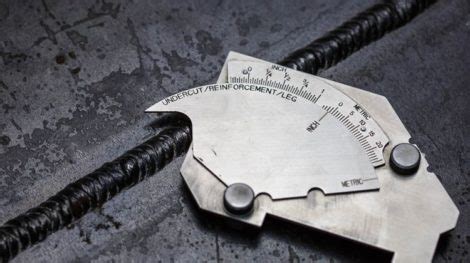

[227,61,388,166]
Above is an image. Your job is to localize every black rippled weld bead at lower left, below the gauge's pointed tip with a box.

[0,126,191,261]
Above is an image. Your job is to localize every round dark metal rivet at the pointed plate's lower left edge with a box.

[224,183,255,215]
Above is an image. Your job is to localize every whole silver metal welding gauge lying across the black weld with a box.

[147,52,459,262]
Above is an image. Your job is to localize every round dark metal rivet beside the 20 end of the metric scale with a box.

[390,143,421,175]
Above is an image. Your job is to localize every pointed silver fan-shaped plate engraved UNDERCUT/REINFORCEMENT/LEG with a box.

[150,83,379,199]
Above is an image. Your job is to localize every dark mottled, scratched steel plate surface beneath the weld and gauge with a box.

[0,0,470,262]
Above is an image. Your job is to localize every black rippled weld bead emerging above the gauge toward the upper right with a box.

[280,0,436,74]
